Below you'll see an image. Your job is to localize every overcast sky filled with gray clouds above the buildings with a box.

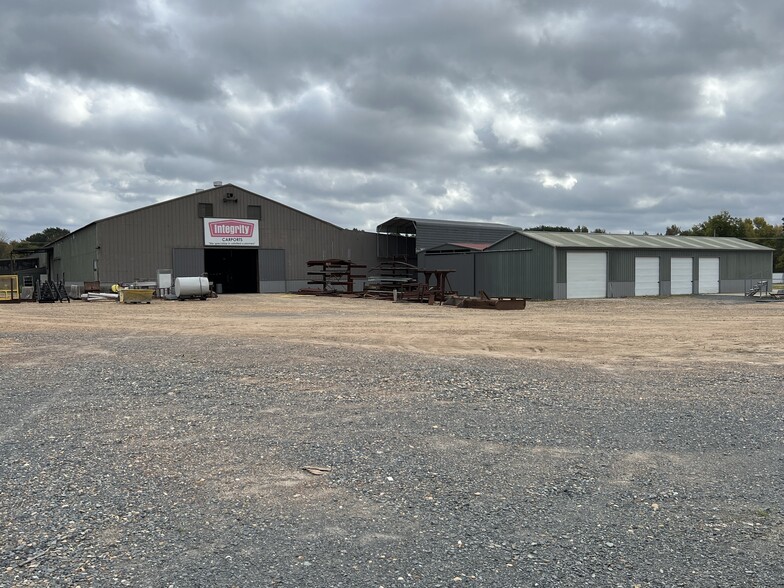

[0,0,784,239]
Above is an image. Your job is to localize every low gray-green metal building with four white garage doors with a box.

[423,231,773,300]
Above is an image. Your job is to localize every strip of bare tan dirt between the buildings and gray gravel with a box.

[0,294,784,368]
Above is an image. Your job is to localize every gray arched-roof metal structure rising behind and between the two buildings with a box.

[376,216,520,264]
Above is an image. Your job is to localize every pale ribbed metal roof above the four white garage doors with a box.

[519,231,772,251]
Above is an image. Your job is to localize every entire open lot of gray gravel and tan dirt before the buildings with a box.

[0,295,784,588]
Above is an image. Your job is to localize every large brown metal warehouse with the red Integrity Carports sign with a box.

[50,182,377,293]
